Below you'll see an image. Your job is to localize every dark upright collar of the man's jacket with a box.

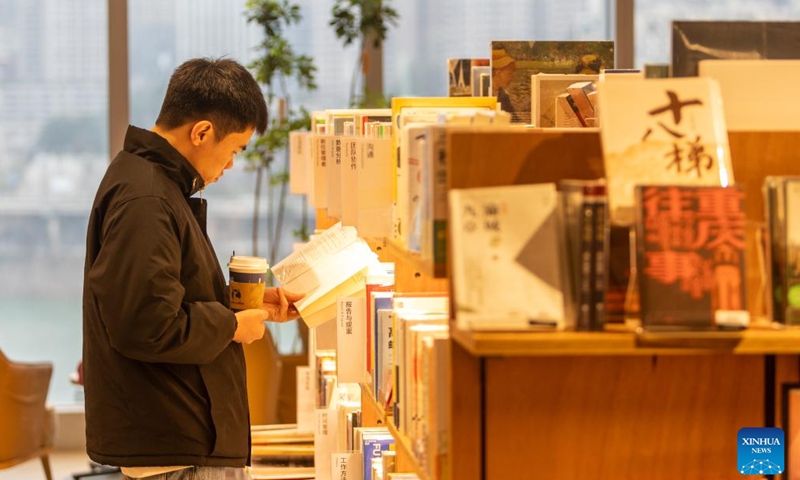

[123,125,205,197]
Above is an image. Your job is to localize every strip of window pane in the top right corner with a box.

[634,0,800,68]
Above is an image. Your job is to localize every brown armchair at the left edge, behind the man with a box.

[0,351,55,480]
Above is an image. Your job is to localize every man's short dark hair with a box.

[156,58,267,140]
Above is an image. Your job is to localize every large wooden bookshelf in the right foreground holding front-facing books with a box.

[440,129,800,480]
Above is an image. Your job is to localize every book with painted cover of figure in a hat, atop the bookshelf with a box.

[491,40,614,124]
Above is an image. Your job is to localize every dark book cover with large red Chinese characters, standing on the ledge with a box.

[636,185,747,329]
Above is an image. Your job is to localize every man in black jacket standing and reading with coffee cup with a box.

[83,59,302,480]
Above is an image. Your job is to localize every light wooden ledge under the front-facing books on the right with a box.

[450,326,800,356]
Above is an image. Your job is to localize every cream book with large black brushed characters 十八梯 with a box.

[598,77,734,225]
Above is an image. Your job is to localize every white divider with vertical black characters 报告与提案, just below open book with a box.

[336,295,367,383]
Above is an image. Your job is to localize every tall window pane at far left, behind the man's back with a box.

[0,0,108,404]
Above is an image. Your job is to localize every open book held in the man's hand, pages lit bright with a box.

[272,223,378,327]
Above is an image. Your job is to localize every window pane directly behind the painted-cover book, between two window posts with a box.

[384,0,613,96]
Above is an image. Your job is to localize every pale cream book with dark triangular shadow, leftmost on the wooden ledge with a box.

[450,183,566,330]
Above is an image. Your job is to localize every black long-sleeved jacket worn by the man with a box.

[83,127,250,467]
